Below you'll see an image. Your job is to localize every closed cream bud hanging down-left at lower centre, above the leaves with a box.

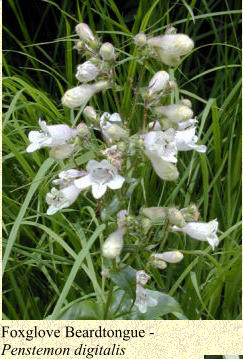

[102,227,126,259]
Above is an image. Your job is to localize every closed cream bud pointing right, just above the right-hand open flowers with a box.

[154,104,193,123]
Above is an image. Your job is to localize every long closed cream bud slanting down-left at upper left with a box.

[62,81,110,108]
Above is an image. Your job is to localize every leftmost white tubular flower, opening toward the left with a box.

[26,119,78,152]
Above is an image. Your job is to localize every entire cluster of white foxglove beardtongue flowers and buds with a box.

[27,23,219,313]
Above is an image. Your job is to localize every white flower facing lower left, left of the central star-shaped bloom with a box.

[46,184,81,215]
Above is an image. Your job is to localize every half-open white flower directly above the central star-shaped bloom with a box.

[100,112,127,143]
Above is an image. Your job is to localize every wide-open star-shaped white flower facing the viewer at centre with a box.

[74,160,125,199]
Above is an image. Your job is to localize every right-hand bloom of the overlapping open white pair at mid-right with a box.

[175,127,207,153]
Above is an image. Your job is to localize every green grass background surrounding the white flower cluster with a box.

[3,0,241,319]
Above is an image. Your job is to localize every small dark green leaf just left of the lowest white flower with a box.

[110,264,136,299]
